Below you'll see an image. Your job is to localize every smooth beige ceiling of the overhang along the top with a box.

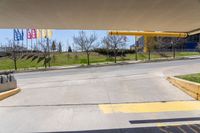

[0,0,200,32]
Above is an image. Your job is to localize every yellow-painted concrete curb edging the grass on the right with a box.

[167,77,200,101]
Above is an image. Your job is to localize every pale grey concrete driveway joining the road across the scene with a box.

[0,59,200,133]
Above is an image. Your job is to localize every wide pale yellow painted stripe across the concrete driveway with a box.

[99,101,200,114]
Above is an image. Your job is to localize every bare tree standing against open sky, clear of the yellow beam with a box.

[73,31,98,65]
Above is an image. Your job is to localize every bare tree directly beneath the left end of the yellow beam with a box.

[102,35,127,63]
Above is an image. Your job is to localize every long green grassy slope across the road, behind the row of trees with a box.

[0,52,199,70]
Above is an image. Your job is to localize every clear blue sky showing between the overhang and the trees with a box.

[0,29,135,47]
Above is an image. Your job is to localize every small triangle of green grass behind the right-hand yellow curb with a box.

[176,73,200,83]
